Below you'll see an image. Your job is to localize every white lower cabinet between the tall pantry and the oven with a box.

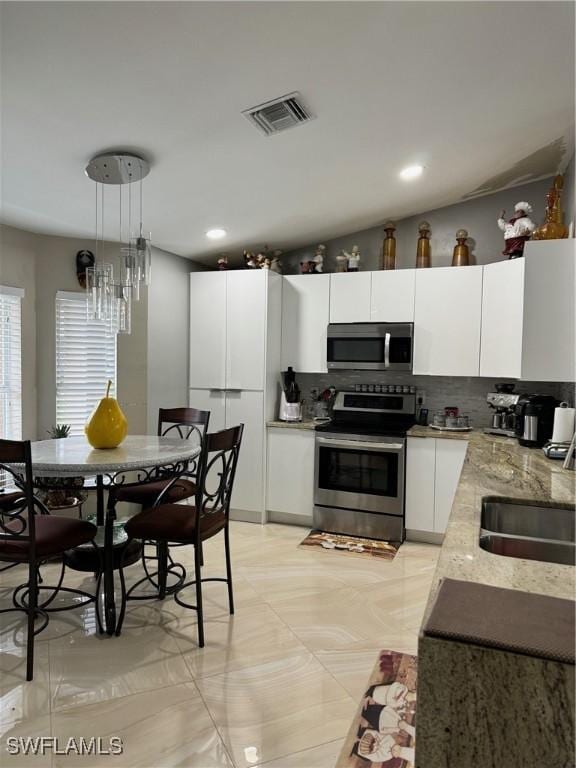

[266,427,315,522]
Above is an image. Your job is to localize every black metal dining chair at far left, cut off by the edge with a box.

[0,440,97,680]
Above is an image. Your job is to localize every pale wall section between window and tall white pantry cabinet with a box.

[147,248,198,433]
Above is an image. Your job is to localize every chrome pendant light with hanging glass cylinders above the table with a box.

[86,152,152,333]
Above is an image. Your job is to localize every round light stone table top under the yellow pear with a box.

[12,435,200,477]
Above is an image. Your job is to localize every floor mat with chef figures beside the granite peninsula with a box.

[336,651,418,768]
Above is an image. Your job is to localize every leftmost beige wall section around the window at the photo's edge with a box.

[0,225,37,440]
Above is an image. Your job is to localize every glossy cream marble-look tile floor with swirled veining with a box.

[0,523,439,768]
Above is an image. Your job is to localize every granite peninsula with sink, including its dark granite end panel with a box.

[410,427,576,768]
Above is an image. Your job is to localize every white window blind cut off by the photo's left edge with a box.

[0,285,24,440]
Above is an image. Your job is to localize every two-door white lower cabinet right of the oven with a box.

[405,437,468,539]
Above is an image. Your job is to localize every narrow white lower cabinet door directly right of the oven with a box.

[405,437,436,532]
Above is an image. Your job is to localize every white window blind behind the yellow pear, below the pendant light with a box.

[56,291,116,435]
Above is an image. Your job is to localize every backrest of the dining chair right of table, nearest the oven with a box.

[196,424,244,529]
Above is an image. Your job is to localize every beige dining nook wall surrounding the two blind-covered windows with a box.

[0,226,197,440]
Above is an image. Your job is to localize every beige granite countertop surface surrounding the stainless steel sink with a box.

[416,428,576,622]
